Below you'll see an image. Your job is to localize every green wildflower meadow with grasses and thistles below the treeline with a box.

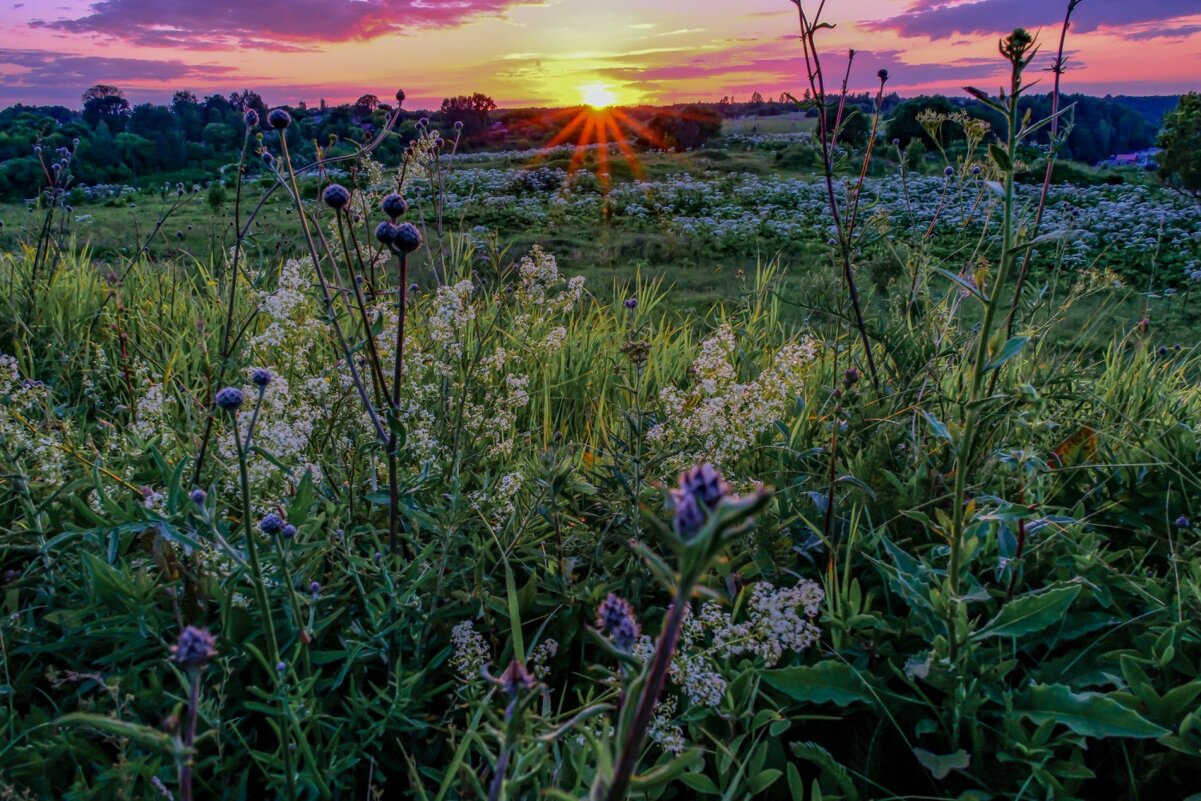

[0,17,1201,801]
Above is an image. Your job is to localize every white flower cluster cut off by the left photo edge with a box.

[0,353,66,484]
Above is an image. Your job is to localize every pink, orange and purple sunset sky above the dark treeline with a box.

[0,0,1201,108]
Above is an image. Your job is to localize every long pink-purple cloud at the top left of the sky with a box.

[30,0,528,49]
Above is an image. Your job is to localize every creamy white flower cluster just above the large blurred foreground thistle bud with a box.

[647,325,817,472]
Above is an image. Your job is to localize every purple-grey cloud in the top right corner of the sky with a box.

[864,0,1199,38]
